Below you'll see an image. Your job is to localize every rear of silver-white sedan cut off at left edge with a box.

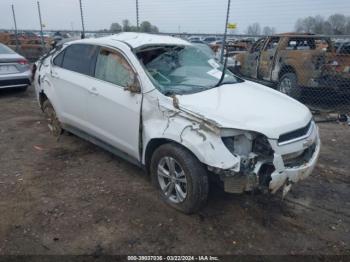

[0,43,32,91]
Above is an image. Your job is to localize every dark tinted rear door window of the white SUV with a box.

[62,44,98,76]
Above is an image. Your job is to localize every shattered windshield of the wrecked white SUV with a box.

[137,45,242,95]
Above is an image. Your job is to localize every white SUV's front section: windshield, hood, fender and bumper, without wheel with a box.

[135,41,320,198]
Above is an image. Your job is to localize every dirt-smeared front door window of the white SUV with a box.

[95,48,134,87]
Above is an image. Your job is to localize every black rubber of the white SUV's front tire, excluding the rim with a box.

[150,143,209,214]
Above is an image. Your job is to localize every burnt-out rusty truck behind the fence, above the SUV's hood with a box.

[234,33,335,99]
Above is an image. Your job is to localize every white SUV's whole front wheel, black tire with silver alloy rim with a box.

[150,143,209,214]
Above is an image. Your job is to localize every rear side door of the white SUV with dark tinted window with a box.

[50,44,98,130]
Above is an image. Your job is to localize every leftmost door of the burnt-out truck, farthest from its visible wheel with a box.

[243,38,266,78]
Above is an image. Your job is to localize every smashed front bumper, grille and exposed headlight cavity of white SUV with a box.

[208,121,320,196]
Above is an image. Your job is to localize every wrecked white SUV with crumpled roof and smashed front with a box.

[35,33,320,213]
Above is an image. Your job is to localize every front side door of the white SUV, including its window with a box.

[88,47,142,160]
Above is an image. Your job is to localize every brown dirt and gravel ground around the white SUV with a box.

[0,87,350,255]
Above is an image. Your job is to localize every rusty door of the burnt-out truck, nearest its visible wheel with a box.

[258,37,280,81]
